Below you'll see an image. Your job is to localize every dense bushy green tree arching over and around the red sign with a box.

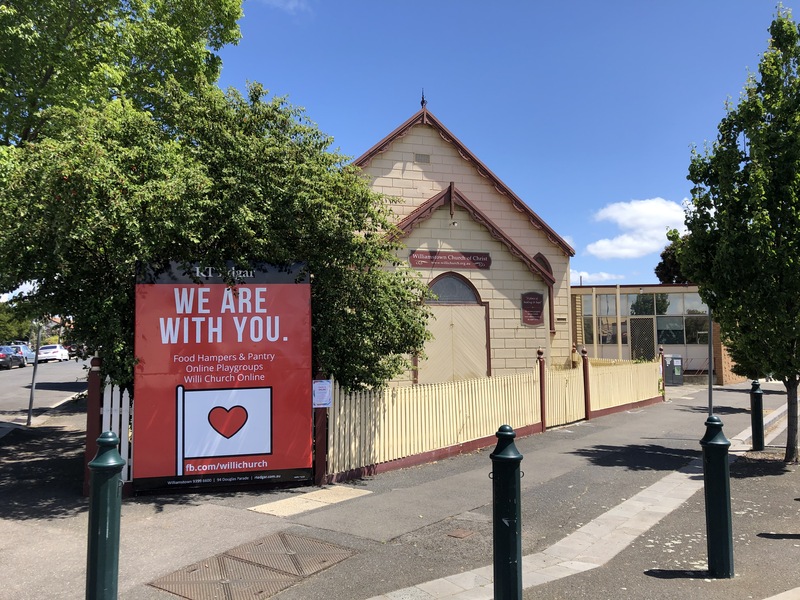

[0,85,427,387]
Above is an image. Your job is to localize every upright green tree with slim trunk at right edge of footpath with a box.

[673,8,800,461]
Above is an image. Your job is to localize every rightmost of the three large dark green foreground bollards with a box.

[700,415,734,579]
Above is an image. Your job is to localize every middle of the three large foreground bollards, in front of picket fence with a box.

[489,425,522,600]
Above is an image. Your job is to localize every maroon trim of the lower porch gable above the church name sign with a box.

[397,182,555,287]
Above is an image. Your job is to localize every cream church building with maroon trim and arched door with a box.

[354,103,574,384]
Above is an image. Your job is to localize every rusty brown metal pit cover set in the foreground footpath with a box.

[150,533,353,600]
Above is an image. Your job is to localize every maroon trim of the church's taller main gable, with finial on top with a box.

[353,104,575,256]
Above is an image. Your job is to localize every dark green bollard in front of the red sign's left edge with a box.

[86,431,125,600]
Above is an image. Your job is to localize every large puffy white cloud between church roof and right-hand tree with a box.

[586,198,686,259]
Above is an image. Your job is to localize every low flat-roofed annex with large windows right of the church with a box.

[572,285,745,385]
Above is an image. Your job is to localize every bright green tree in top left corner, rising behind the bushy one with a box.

[0,0,242,144]
